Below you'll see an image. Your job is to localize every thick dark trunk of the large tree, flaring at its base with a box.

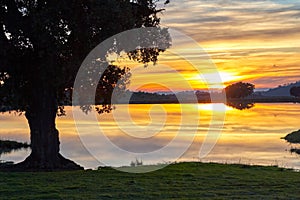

[15,86,83,171]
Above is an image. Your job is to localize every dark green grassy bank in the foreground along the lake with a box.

[0,162,300,200]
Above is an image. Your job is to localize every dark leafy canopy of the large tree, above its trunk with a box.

[0,0,170,111]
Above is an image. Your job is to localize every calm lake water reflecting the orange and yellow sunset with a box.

[0,103,300,169]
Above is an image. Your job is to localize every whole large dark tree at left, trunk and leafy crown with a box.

[0,0,169,170]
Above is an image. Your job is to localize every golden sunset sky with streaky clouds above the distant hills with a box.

[123,0,300,91]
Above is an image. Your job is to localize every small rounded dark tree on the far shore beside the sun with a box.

[225,82,255,98]
